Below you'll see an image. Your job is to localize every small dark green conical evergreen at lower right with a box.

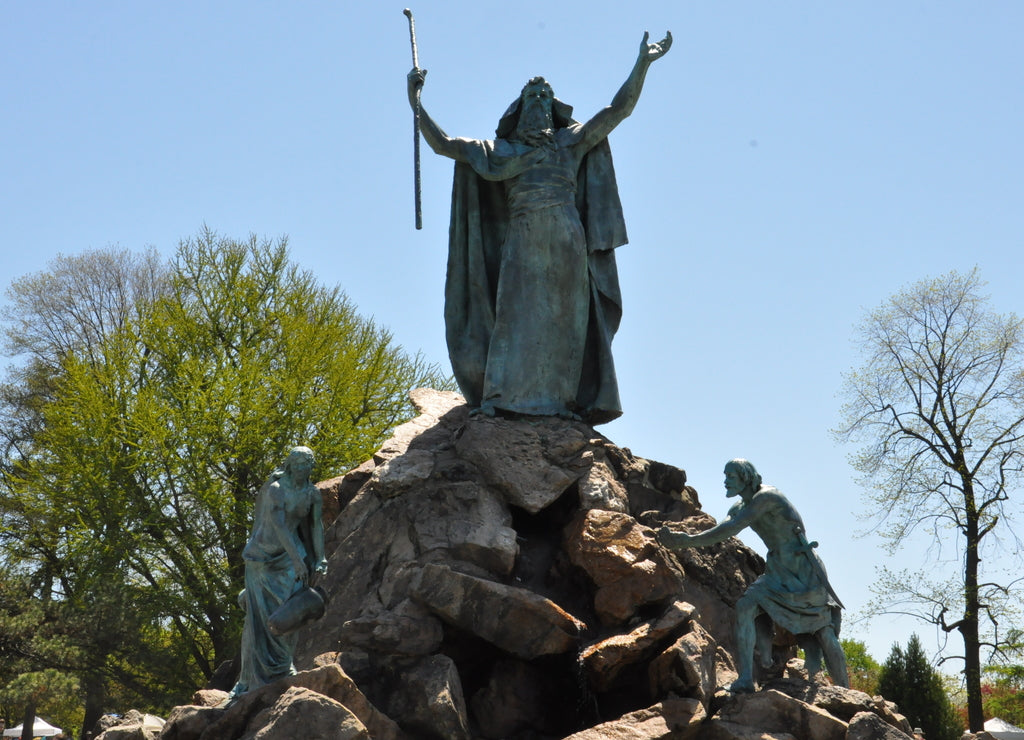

[879,635,964,740]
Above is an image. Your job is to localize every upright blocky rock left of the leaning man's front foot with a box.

[647,621,724,707]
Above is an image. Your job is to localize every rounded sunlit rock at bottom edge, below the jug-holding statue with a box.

[246,687,371,740]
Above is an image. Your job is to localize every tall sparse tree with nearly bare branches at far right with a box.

[837,270,1024,732]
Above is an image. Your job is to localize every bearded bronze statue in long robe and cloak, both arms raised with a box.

[409,34,672,424]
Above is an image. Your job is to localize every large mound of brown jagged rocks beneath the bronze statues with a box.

[162,389,909,740]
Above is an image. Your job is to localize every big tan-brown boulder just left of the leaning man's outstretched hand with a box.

[565,510,683,625]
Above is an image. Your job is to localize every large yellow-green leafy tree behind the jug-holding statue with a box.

[0,230,452,727]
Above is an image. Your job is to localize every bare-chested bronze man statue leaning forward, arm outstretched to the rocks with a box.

[657,459,850,692]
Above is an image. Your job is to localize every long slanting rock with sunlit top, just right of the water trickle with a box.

[580,602,694,691]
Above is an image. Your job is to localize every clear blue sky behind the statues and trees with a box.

[0,0,1024,671]
